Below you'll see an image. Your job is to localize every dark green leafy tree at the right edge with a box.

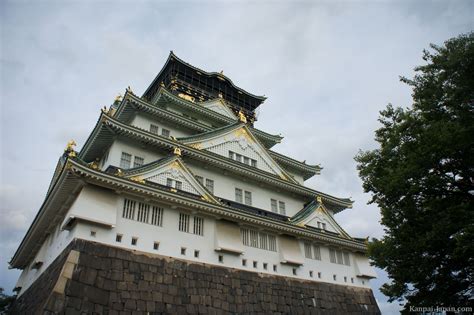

[355,32,474,310]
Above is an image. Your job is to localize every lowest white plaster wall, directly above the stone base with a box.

[17,190,369,294]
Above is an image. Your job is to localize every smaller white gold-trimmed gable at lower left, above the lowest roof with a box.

[122,155,219,203]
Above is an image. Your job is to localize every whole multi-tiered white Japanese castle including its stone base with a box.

[10,52,380,314]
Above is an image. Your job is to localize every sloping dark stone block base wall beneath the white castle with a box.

[11,240,380,314]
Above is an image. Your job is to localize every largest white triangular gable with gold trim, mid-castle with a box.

[179,123,295,182]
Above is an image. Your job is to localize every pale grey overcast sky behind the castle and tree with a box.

[0,1,474,314]
